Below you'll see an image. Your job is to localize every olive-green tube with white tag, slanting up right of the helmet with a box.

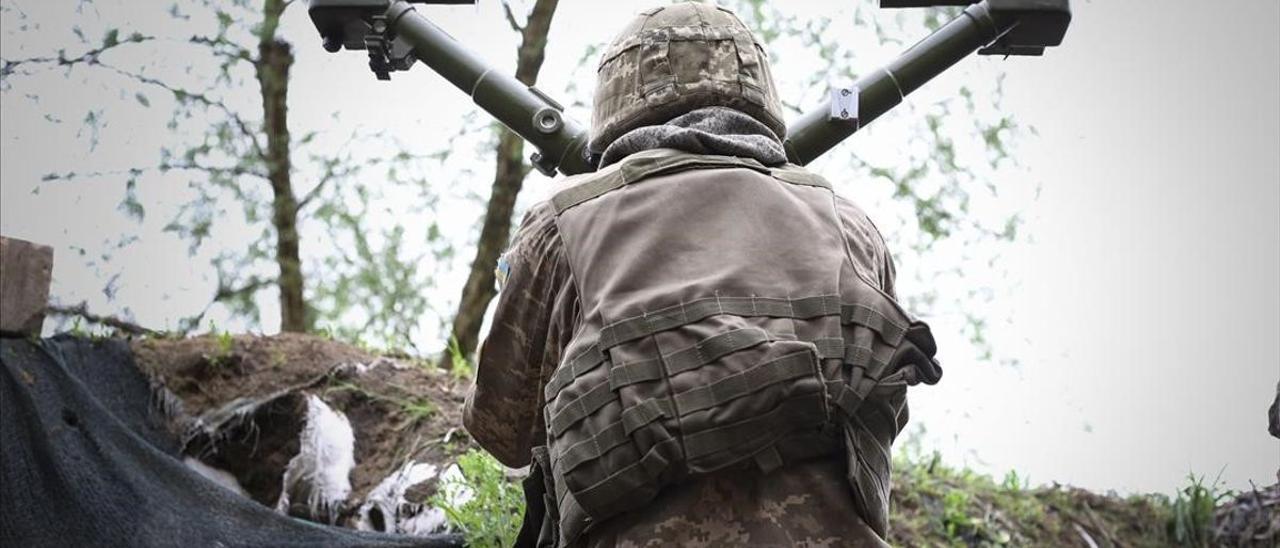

[786,0,1016,165]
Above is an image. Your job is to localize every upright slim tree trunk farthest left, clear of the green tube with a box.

[255,0,307,333]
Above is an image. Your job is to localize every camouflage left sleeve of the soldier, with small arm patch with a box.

[462,204,577,467]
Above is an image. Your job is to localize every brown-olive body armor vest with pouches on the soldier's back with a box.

[535,150,941,544]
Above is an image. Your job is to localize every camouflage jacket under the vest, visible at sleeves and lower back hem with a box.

[465,176,908,545]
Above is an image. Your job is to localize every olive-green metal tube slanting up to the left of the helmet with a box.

[387,0,595,174]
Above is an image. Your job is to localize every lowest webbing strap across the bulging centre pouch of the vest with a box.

[684,391,826,461]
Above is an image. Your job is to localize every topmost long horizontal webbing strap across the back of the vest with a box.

[600,294,841,348]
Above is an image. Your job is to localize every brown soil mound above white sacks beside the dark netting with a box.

[133,334,471,503]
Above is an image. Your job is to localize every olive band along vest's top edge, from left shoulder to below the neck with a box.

[552,150,769,215]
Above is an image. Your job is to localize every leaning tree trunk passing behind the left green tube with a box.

[452,0,558,356]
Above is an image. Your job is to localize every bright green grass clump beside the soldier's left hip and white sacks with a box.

[431,449,525,548]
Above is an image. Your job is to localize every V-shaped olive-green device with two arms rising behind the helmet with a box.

[307,0,1071,175]
